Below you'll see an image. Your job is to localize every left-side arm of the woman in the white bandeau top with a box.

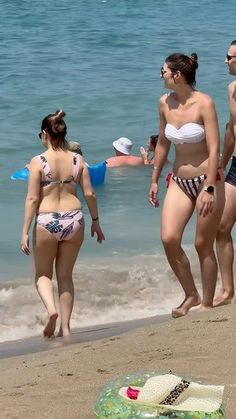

[149,95,170,207]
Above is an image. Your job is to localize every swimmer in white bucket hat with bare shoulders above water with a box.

[106,137,143,167]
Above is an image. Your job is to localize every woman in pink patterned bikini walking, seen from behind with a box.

[21,110,104,337]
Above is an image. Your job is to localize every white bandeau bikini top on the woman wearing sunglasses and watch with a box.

[165,122,205,144]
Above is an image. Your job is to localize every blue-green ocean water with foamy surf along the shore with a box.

[0,0,236,341]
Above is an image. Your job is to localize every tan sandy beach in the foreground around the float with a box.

[0,304,236,419]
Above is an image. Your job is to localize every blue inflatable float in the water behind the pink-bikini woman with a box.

[11,161,106,186]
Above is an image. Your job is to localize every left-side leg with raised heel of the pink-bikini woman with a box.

[33,225,58,337]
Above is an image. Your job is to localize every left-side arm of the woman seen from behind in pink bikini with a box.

[21,157,41,255]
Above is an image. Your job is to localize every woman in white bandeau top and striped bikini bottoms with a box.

[149,53,225,317]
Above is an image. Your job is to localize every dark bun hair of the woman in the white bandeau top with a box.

[166,52,198,87]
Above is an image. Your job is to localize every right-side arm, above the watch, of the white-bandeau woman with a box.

[202,95,220,186]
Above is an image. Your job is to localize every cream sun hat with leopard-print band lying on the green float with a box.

[119,374,224,413]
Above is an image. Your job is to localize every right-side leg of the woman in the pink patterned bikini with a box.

[56,226,84,336]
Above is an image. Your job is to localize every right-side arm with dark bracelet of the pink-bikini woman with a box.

[79,159,105,243]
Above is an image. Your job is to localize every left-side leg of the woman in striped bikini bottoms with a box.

[161,180,201,317]
